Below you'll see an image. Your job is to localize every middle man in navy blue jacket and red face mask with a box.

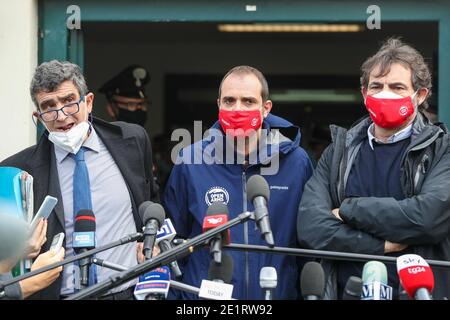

[164,66,312,299]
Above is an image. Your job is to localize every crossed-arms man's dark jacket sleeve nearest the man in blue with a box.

[297,144,384,255]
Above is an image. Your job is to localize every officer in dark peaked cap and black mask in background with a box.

[99,65,150,126]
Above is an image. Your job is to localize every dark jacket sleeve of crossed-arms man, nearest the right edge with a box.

[340,139,450,245]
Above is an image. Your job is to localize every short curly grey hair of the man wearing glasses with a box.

[30,60,88,109]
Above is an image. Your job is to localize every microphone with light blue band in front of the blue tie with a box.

[73,209,96,288]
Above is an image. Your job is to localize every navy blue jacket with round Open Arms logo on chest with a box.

[164,115,312,300]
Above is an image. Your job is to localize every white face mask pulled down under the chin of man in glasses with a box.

[47,121,90,154]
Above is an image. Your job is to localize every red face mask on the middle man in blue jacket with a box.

[219,109,262,137]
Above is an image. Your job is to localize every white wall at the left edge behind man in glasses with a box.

[0,0,38,161]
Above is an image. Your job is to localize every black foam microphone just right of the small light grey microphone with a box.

[300,261,325,300]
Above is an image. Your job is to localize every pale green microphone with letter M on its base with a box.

[361,261,392,300]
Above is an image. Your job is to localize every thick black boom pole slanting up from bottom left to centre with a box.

[66,212,254,300]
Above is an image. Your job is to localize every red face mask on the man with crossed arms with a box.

[365,91,417,129]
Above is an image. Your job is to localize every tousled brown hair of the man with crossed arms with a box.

[360,38,432,109]
